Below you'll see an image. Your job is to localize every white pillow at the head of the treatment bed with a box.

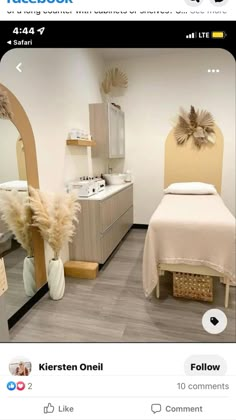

[164,182,217,195]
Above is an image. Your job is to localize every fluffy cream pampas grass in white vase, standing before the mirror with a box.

[29,187,81,300]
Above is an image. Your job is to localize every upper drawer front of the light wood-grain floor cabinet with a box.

[100,186,133,233]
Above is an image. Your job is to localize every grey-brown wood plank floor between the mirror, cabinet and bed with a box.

[10,229,236,342]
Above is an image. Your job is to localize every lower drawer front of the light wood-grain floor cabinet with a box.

[100,207,133,264]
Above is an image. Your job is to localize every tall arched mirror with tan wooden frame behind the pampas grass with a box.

[0,84,46,319]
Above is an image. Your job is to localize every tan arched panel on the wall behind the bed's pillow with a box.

[164,126,224,194]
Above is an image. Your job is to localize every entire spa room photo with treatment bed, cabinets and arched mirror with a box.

[0,48,236,342]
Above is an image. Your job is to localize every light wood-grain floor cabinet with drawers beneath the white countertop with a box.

[70,185,133,264]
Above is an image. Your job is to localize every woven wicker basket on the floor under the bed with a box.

[173,272,213,302]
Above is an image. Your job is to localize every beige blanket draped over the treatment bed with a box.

[143,194,236,296]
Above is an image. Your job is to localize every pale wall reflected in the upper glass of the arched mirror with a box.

[0,119,19,183]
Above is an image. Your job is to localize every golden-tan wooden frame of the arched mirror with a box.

[0,83,47,288]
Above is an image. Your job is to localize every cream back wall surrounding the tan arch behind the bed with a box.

[107,49,235,223]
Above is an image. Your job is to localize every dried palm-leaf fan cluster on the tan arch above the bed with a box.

[174,106,215,149]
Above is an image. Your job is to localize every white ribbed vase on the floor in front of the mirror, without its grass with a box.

[48,258,65,300]
